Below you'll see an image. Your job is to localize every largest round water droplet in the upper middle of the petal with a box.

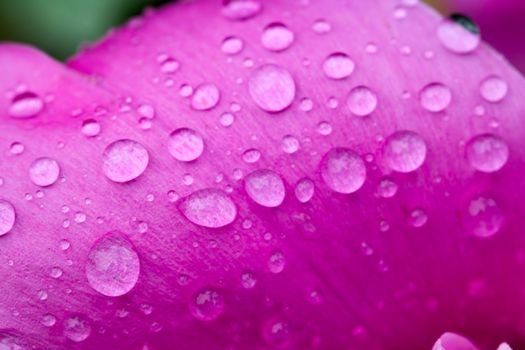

[248,64,296,112]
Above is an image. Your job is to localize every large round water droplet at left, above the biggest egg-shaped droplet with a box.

[102,139,149,183]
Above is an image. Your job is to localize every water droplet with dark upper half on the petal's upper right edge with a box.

[437,15,481,54]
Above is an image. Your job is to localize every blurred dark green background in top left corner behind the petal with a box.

[0,0,442,60]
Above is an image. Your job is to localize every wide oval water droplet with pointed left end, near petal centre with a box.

[178,188,237,228]
